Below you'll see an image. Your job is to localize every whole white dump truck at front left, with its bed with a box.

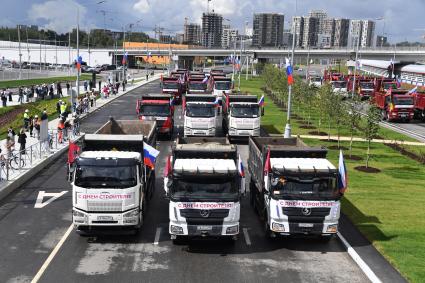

[71,119,156,234]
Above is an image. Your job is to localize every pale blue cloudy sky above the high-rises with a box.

[0,0,425,42]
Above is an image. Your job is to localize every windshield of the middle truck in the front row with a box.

[171,175,238,201]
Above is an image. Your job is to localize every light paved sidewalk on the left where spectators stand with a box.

[0,74,160,192]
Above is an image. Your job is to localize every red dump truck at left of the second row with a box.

[136,94,174,139]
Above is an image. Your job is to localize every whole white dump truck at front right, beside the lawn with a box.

[248,137,342,239]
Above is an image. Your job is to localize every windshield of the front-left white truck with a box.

[75,165,137,188]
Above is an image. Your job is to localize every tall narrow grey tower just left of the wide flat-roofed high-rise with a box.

[202,13,223,48]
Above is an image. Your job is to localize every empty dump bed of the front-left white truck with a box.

[83,118,156,152]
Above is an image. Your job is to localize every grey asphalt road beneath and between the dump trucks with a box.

[0,82,401,283]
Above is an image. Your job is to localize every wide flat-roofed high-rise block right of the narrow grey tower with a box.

[252,13,285,47]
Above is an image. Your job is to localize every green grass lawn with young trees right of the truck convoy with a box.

[242,75,425,282]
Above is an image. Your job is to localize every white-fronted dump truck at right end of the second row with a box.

[222,94,262,138]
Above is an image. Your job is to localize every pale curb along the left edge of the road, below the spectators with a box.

[0,77,159,201]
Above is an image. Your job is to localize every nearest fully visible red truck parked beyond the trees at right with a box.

[374,89,414,122]
